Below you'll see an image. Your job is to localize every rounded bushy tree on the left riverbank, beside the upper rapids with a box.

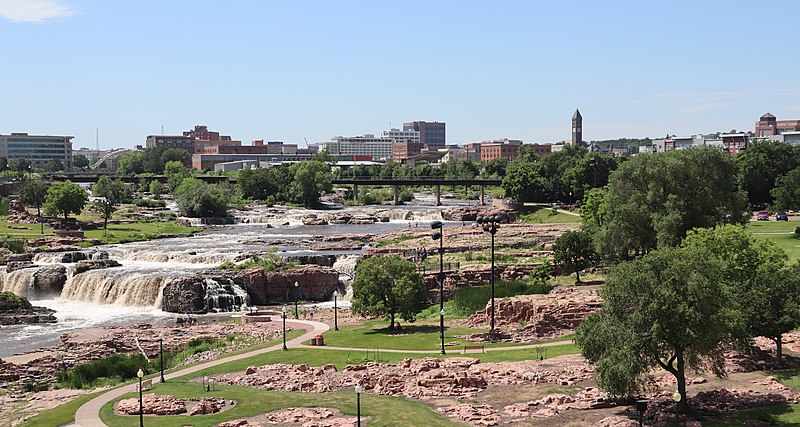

[174,178,231,218]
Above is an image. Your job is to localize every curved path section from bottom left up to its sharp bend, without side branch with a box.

[74,319,330,427]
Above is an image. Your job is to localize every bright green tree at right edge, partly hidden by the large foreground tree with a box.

[684,225,800,364]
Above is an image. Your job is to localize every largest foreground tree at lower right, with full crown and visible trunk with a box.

[576,247,747,409]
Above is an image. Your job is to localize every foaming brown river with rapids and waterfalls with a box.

[0,194,477,357]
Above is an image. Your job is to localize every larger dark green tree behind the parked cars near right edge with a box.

[736,141,800,205]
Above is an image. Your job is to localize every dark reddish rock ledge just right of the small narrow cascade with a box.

[233,265,339,304]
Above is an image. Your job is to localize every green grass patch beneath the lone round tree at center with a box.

[324,320,540,350]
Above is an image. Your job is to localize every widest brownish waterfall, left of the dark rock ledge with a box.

[61,268,173,308]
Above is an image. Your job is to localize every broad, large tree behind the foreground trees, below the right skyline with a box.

[596,148,750,259]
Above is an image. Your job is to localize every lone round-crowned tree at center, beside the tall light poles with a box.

[352,256,428,331]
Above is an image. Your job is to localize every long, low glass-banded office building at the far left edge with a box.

[0,133,74,170]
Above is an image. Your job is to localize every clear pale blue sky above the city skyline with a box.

[0,0,800,148]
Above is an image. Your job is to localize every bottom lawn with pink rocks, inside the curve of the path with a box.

[100,380,459,427]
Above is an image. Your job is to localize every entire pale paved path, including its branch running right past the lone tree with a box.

[74,319,573,427]
